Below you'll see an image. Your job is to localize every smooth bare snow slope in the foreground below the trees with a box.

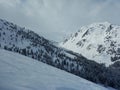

[0,49,113,90]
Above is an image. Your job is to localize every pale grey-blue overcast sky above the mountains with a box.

[0,0,120,41]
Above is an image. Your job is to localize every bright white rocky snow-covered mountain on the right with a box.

[60,22,120,66]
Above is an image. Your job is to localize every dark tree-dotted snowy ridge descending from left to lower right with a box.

[0,19,120,89]
